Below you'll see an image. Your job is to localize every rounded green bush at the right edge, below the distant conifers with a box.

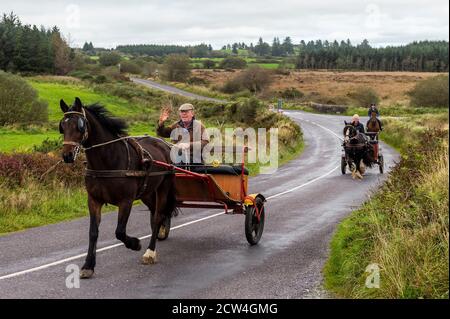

[408,75,449,107]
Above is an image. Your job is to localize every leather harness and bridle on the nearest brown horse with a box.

[59,108,174,198]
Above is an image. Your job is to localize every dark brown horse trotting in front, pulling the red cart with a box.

[60,98,176,278]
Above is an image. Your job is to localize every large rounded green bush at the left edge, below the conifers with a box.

[0,71,48,125]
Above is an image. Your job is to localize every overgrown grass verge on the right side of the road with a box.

[323,114,449,298]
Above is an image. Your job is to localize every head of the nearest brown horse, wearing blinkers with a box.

[59,97,88,163]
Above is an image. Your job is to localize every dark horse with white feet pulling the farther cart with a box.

[343,122,374,179]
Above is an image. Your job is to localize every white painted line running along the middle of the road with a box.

[0,115,340,280]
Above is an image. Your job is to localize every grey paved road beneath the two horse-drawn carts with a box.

[0,108,399,298]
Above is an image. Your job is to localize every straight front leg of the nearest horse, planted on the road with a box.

[80,196,103,279]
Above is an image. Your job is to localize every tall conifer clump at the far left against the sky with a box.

[0,13,74,74]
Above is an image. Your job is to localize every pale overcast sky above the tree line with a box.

[0,0,449,49]
